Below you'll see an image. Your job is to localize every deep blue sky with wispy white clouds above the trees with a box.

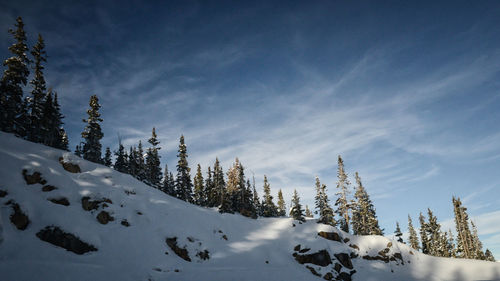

[0,1,500,259]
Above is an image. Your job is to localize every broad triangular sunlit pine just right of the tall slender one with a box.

[352,172,383,235]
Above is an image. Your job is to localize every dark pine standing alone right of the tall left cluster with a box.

[82,95,104,163]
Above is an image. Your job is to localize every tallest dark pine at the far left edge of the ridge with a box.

[0,17,30,133]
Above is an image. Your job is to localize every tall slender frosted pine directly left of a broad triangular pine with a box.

[335,155,350,232]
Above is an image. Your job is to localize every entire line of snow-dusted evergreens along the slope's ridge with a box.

[0,17,494,261]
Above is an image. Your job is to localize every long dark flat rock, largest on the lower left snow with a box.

[36,226,97,255]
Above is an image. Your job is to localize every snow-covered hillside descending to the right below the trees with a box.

[0,133,500,281]
